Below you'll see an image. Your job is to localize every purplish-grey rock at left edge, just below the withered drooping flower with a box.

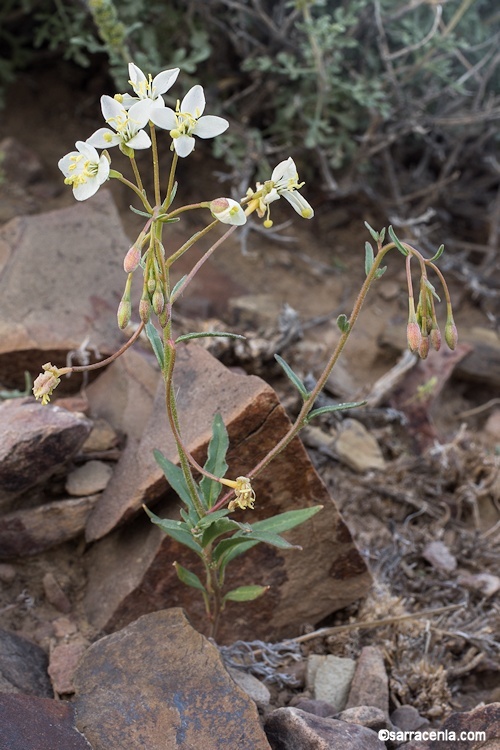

[0,398,91,511]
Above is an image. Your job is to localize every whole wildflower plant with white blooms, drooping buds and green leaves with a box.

[33,63,457,636]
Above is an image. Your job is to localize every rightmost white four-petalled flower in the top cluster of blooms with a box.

[150,85,229,156]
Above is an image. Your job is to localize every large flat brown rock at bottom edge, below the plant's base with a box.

[73,609,269,750]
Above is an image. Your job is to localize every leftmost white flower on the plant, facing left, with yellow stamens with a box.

[58,141,109,201]
